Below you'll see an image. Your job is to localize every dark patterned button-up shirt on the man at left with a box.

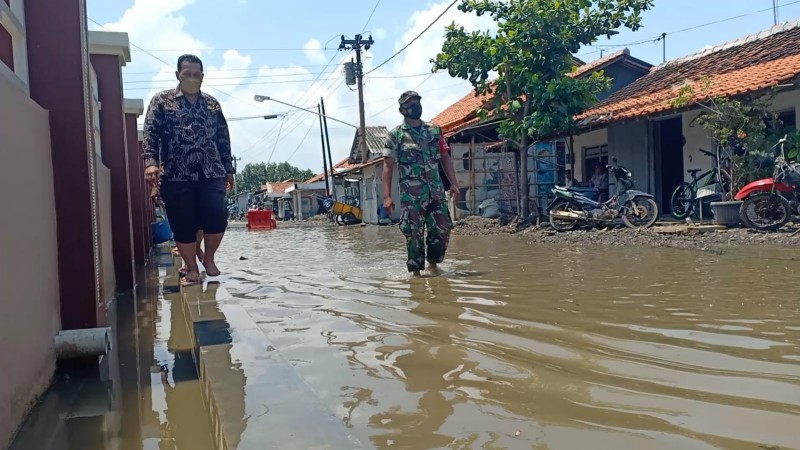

[142,88,234,181]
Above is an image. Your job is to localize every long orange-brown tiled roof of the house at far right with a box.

[578,22,800,126]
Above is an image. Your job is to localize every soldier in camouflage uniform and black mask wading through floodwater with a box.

[383,91,458,276]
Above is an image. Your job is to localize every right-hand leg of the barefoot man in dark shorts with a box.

[198,179,228,277]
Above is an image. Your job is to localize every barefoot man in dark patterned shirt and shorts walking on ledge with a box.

[143,55,235,285]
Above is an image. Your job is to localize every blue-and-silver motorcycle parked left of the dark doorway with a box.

[547,158,658,231]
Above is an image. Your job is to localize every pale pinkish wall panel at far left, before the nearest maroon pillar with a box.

[0,75,60,448]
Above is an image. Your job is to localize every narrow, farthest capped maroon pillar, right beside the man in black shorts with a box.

[125,98,148,265]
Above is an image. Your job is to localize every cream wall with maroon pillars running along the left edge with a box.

[0,0,149,448]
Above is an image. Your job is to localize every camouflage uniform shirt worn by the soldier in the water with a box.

[383,122,444,202]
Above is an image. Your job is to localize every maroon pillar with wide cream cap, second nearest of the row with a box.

[89,31,134,289]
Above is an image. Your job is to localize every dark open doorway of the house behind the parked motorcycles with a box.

[654,116,685,214]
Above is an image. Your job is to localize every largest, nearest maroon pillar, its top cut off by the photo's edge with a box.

[25,0,106,329]
